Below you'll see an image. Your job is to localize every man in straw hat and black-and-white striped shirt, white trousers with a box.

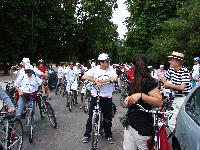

[161,52,191,131]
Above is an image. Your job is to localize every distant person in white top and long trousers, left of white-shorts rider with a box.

[55,62,65,95]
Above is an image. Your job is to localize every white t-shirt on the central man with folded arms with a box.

[85,65,117,98]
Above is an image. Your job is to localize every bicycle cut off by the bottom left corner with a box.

[0,106,23,150]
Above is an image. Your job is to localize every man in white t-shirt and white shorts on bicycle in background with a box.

[64,62,78,107]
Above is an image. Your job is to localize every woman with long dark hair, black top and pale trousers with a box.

[123,54,162,150]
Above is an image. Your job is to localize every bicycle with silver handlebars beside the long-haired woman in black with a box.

[136,104,173,150]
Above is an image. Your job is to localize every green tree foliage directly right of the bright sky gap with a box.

[125,0,184,63]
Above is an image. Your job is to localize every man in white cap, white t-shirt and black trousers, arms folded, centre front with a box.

[82,53,117,144]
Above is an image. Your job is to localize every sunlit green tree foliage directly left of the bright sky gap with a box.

[77,0,118,62]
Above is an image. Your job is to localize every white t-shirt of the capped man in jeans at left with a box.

[14,74,42,93]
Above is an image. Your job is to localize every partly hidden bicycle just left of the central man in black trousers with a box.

[80,82,91,113]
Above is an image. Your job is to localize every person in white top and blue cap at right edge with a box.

[192,57,200,86]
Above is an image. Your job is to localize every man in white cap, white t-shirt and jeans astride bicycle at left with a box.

[14,65,42,117]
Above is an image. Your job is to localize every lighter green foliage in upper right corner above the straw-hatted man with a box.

[152,0,200,61]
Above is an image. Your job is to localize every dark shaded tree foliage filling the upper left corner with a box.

[0,0,77,62]
